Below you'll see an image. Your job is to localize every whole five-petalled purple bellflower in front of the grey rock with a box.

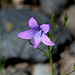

[18,17,55,48]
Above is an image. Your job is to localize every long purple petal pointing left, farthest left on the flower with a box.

[18,29,35,39]
